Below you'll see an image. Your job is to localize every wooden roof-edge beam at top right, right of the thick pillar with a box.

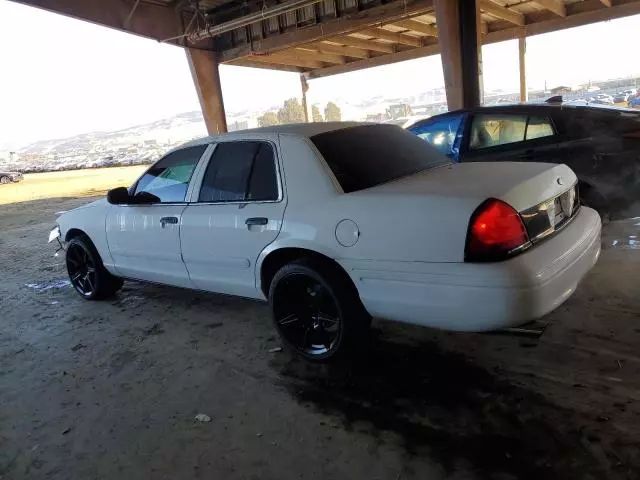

[483,0,640,45]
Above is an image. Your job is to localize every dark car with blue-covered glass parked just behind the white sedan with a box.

[408,97,640,218]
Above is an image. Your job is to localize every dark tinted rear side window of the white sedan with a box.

[198,141,278,202]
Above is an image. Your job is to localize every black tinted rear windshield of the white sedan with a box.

[311,125,451,193]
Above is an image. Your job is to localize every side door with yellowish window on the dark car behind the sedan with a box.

[461,112,558,163]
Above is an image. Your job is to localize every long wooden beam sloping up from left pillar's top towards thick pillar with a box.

[218,0,433,62]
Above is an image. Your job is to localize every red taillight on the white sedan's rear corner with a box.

[465,199,530,262]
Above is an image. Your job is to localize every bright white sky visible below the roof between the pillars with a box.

[0,0,640,150]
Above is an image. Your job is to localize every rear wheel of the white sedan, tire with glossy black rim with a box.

[269,258,371,362]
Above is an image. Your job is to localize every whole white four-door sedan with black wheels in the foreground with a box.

[50,123,600,360]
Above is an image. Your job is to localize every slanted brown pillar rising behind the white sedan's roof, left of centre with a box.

[185,48,227,135]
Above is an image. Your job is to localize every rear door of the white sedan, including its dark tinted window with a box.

[180,140,285,298]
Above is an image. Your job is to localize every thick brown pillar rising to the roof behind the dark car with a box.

[435,0,480,110]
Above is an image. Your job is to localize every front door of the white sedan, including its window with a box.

[106,145,207,287]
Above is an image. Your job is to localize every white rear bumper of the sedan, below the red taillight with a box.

[345,207,601,332]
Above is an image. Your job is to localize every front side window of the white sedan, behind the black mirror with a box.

[134,145,207,203]
